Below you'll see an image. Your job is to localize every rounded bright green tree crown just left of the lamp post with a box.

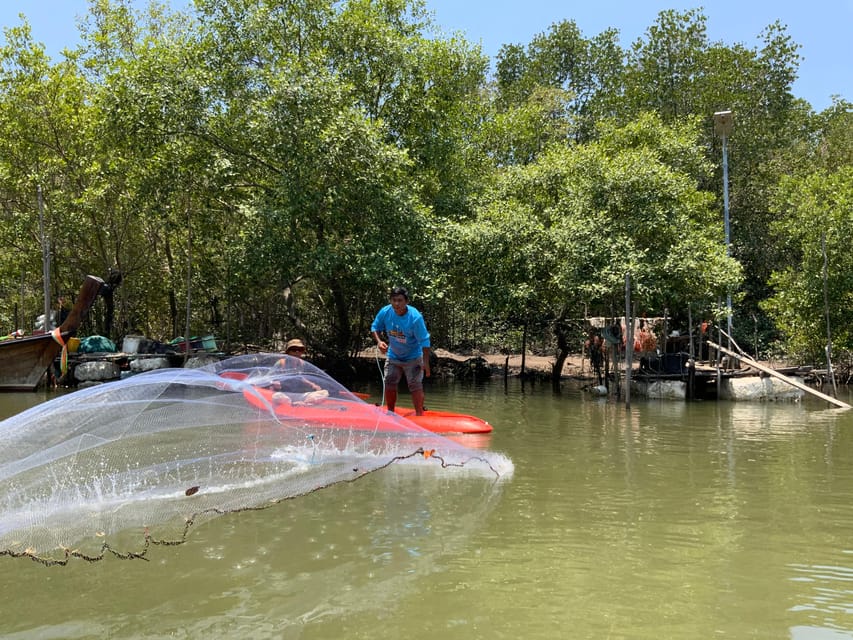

[446,115,739,336]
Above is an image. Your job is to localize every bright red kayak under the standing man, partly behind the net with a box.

[243,386,492,434]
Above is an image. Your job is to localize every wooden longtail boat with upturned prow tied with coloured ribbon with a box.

[0,276,104,391]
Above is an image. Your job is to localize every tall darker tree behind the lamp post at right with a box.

[623,9,808,313]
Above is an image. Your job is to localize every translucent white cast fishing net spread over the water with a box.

[0,354,513,565]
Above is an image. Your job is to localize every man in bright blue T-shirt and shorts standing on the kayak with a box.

[370,287,430,416]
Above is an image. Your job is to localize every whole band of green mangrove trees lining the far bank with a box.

[0,0,853,370]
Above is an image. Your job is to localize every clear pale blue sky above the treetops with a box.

[0,0,853,111]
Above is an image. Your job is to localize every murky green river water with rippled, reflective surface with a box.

[0,381,853,640]
